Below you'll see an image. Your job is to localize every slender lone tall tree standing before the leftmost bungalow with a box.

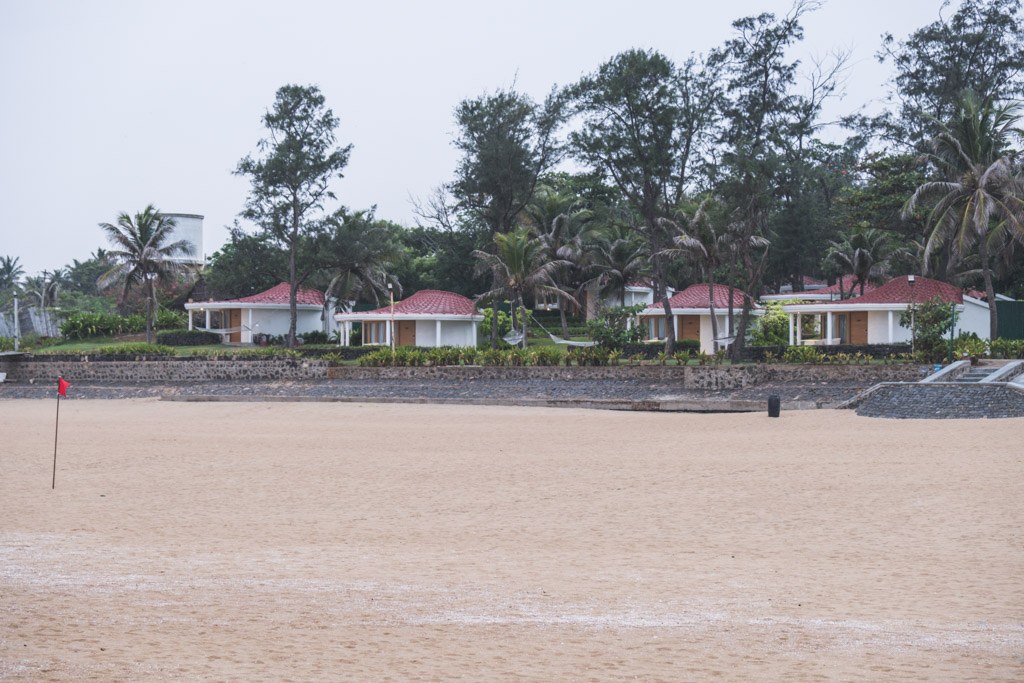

[234,85,352,346]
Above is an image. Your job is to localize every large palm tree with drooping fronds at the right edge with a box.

[903,93,1024,339]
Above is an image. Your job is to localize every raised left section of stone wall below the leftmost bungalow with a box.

[0,355,329,384]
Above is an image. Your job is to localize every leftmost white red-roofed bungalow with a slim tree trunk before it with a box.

[185,283,337,344]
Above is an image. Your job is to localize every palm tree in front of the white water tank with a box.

[97,204,196,342]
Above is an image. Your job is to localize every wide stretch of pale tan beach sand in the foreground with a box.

[0,399,1024,681]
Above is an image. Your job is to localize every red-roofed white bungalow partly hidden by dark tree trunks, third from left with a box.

[640,285,761,353]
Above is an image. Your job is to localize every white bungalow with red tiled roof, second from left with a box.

[334,290,483,346]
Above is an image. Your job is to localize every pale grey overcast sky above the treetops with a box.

[0,0,952,275]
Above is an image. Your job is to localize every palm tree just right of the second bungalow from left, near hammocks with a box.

[473,227,574,348]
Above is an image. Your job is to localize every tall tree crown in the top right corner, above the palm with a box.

[876,0,1024,152]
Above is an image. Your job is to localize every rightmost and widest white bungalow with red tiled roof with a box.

[782,275,989,345]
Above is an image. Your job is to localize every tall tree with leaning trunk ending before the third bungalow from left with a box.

[568,49,718,352]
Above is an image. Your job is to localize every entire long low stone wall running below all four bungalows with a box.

[0,355,924,390]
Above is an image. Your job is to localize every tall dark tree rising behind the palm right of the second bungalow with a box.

[446,88,562,346]
